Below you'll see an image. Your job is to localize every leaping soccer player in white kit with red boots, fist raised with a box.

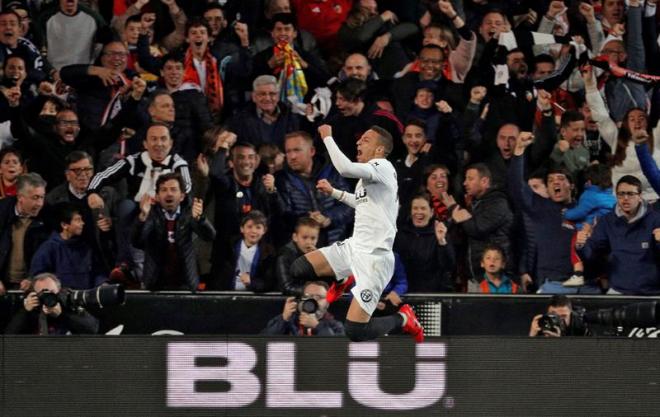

[291,125,424,343]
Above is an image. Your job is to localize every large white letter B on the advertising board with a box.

[167,342,261,408]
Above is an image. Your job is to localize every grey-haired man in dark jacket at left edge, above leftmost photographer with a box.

[0,173,48,295]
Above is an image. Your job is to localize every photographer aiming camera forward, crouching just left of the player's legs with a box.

[261,281,344,336]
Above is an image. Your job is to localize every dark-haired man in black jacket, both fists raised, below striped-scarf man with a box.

[133,173,215,291]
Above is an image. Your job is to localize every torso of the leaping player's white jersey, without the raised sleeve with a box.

[353,159,399,253]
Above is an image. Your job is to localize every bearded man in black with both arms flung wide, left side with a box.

[10,78,146,189]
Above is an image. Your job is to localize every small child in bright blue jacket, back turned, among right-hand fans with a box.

[563,164,616,287]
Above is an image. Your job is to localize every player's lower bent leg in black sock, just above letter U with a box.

[344,298,403,342]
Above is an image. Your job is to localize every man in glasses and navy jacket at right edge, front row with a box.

[575,175,660,295]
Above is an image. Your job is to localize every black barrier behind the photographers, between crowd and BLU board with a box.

[0,291,660,336]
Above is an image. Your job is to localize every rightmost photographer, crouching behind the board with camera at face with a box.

[529,295,591,337]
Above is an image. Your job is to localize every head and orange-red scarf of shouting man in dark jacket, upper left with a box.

[183,19,223,115]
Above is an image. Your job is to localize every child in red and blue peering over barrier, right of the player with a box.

[468,244,521,294]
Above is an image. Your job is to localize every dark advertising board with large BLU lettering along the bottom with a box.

[0,336,660,417]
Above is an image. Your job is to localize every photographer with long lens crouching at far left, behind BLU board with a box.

[5,272,99,335]
